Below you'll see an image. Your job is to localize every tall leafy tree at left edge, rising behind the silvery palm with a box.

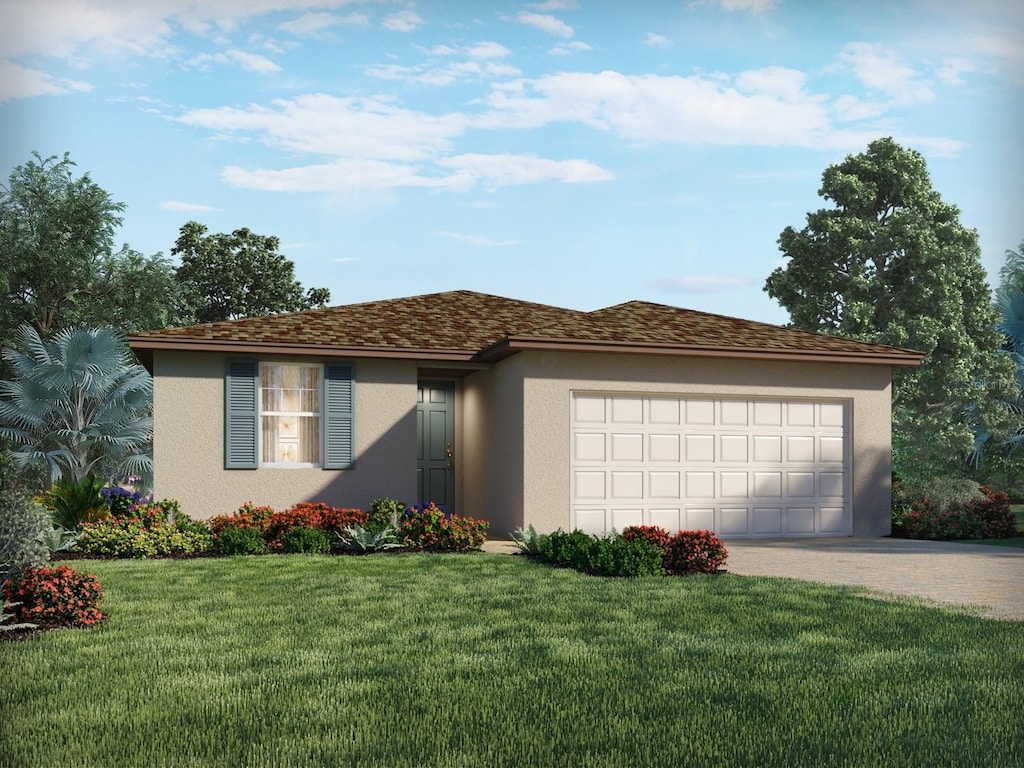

[0,153,177,345]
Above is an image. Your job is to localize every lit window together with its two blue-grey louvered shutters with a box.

[224,359,354,469]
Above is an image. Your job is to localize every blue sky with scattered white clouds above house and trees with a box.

[0,0,1024,323]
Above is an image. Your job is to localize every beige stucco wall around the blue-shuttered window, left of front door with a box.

[153,351,416,518]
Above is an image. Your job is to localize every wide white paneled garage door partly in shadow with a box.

[570,392,852,537]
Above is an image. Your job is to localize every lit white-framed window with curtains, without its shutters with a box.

[259,362,322,466]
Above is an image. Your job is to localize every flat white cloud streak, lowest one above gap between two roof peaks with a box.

[437,154,614,187]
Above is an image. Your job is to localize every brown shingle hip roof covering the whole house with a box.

[129,291,921,365]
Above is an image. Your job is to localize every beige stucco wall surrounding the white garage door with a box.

[466,351,891,536]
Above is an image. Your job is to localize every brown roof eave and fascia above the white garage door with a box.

[477,336,925,368]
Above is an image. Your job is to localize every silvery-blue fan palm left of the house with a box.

[0,326,153,482]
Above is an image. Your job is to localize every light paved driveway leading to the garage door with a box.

[725,538,1024,622]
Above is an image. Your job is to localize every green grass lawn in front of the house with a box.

[0,554,1024,768]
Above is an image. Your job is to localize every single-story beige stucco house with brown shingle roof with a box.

[129,291,922,537]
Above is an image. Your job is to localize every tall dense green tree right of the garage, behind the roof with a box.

[765,138,1014,479]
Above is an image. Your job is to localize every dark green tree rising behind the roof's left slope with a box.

[171,221,331,323]
